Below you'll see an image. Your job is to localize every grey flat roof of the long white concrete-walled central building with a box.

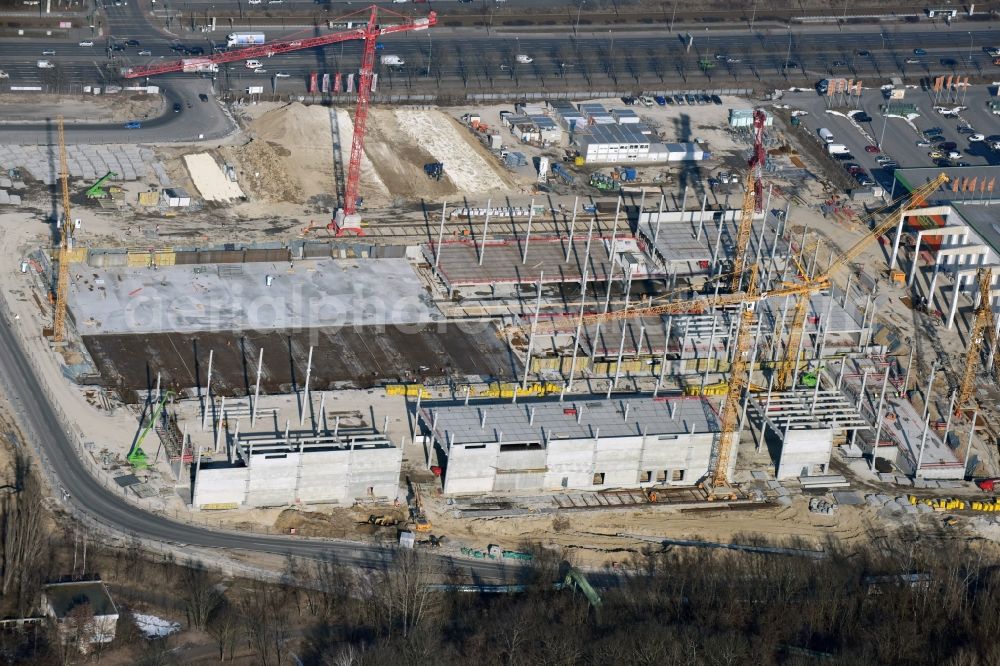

[420,395,720,445]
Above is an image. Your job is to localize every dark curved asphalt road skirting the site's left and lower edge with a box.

[0,300,521,581]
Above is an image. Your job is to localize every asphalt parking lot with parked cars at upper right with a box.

[782,86,1000,190]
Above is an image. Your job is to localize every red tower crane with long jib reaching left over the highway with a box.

[122,5,437,236]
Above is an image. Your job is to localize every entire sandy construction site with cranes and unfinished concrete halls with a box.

[0,10,1000,565]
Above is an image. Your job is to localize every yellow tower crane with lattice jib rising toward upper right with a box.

[774,173,948,390]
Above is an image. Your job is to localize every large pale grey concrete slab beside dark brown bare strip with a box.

[69,259,444,335]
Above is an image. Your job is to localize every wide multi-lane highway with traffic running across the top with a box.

[0,20,1000,92]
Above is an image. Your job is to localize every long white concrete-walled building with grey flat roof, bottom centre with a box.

[418,396,735,495]
